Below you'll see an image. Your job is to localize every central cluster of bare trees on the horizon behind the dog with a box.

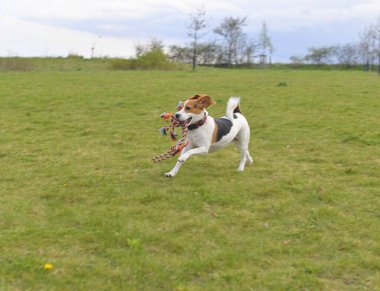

[136,8,274,70]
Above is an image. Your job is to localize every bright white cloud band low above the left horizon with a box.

[0,17,138,57]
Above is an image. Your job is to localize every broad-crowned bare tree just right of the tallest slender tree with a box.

[214,17,247,67]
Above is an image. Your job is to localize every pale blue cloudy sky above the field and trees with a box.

[0,0,380,62]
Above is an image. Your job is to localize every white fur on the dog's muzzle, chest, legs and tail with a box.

[165,97,252,177]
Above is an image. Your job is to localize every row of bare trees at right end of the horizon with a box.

[290,18,380,73]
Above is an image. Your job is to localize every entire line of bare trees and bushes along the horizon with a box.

[131,9,380,73]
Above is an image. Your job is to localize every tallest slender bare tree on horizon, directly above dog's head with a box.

[188,7,206,71]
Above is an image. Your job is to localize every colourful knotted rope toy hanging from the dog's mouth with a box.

[152,101,189,163]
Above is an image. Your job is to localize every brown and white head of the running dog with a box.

[175,94,215,122]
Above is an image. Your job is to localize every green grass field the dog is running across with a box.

[0,69,380,290]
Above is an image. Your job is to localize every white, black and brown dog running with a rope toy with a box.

[165,94,253,178]
